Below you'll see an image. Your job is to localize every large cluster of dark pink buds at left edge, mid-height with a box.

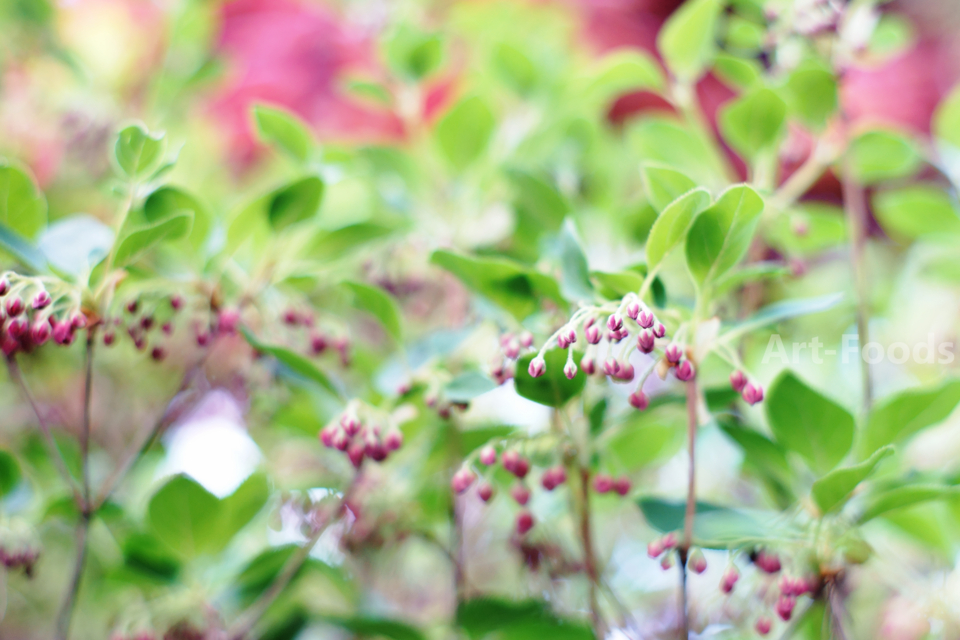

[0,273,87,358]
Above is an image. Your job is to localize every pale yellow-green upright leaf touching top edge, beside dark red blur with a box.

[657,0,720,82]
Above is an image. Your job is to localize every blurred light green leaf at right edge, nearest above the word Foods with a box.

[873,184,960,241]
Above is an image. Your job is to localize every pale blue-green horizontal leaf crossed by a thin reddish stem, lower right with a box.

[637,497,778,549]
